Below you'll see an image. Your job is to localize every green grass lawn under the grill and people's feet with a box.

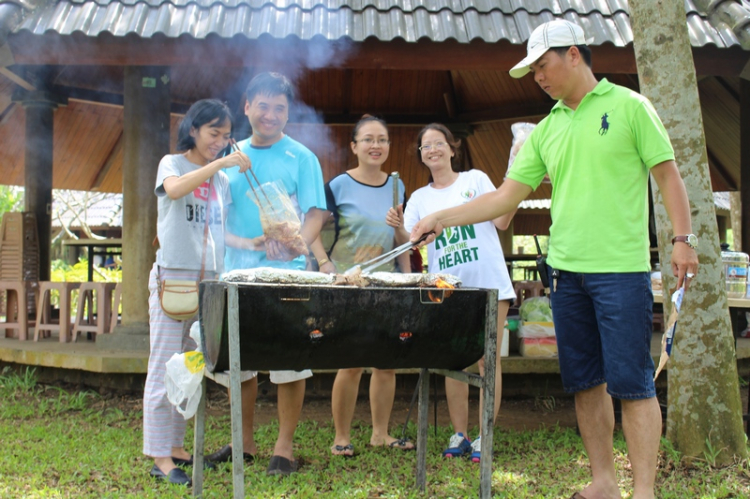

[0,369,750,499]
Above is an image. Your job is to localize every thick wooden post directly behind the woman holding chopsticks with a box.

[103,66,170,350]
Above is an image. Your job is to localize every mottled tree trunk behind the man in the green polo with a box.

[629,0,747,465]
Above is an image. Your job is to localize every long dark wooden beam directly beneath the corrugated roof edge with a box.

[8,31,750,76]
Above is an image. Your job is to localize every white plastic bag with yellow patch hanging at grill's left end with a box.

[164,321,206,419]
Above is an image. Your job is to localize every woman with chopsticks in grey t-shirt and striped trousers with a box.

[143,99,250,485]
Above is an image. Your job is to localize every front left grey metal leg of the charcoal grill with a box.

[227,285,245,499]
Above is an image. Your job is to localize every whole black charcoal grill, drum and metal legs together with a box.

[193,281,497,498]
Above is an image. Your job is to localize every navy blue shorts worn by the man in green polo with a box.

[549,269,656,400]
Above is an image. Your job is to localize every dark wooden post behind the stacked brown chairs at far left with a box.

[13,90,64,281]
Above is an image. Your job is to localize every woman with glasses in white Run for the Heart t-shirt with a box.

[386,123,516,462]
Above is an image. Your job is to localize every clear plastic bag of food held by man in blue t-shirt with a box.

[247,182,309,256]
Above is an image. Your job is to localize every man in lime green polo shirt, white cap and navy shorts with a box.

[411,20,698,499]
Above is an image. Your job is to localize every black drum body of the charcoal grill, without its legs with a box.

[201,282,494,372]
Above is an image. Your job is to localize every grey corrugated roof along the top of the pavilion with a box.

[14,0,750,47]
